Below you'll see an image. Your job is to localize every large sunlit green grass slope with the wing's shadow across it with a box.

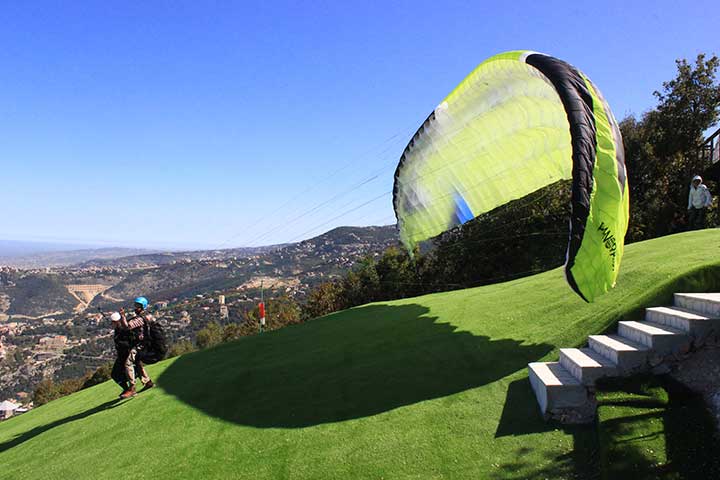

[0,230,720,479]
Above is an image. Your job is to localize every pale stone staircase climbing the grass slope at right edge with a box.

[528,293,720,423]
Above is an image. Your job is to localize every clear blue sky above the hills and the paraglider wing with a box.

[0,0,720,248]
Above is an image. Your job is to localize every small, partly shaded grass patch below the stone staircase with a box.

[597,375,720,480]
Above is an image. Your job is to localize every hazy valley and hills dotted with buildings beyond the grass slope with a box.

[0,227,397,402]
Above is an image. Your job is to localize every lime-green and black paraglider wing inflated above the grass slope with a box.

[393,51,629,301]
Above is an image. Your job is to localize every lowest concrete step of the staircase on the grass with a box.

[528,362,588,415]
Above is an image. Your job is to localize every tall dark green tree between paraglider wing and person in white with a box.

[620,54,720,242]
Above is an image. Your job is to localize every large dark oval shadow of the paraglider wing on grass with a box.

[158,304,552,428]
